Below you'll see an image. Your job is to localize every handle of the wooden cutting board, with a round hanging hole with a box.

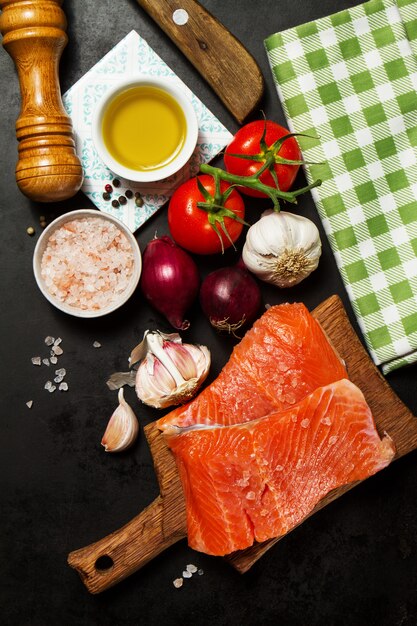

[68,496,187,593]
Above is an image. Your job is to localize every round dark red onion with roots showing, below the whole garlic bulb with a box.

[200,266,261,334]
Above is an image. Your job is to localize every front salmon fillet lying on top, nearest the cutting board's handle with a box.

[167,380,395,556]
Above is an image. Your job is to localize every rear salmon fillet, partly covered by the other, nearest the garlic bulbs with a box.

[157,304,347,434]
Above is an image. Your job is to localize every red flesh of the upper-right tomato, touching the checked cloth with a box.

[224,120,301,198]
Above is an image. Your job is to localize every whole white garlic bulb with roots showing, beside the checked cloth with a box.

[242,209,321,287]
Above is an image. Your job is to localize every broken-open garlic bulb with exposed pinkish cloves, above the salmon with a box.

[134,331,211,409]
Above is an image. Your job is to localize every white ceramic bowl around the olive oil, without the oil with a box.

[91,75,198,183]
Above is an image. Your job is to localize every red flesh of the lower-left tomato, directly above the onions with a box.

[168,174,245,254]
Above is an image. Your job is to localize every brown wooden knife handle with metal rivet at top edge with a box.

[137,0,264,123]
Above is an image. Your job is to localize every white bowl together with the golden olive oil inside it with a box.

[92,76,198,183]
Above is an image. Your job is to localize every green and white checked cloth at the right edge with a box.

[265,0,417,373]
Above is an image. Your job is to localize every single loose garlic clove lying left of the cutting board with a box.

[101,388,139,452]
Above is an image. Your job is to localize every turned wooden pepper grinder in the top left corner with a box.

[0,0,83,202]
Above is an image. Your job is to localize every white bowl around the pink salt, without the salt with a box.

[33,209,142,318]
